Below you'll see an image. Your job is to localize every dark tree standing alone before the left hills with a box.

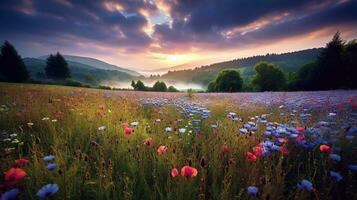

[45,52,70,80]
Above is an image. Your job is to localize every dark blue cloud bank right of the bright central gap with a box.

[155,0,357,47]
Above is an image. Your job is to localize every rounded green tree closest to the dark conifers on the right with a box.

[252,62,286,91]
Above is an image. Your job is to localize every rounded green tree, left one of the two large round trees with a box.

[208,69,243,92]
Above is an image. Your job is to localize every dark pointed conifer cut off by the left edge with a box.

[0,41,29,82]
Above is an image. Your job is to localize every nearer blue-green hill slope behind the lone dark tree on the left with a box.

[23,58,136,85]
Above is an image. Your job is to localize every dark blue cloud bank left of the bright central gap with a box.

[0,0,157,54]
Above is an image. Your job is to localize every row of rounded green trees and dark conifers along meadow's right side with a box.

[207,32,357,92]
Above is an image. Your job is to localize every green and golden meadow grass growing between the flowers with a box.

[0,83,357,200]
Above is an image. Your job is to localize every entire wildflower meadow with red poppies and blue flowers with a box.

[0,83,357,200]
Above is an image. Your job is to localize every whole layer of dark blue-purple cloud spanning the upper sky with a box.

[0,0,357,57]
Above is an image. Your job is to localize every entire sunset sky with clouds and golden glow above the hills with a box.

[0,0,357,71]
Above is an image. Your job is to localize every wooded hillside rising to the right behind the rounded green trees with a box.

[154,48,322,85]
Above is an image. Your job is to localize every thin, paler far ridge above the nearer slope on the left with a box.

[39,55,141,76]
